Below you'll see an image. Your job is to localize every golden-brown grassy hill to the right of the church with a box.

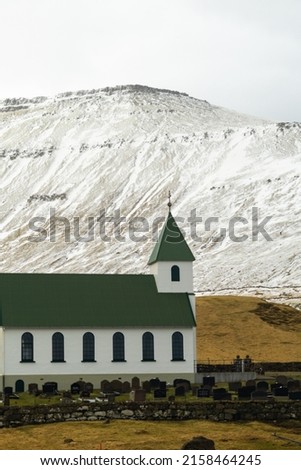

[196,295,301,362]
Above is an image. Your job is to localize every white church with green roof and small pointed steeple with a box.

[0,207,196,392]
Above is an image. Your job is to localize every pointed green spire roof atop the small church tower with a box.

[148,212,195,264]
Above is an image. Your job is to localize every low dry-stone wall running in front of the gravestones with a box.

[0,400,301,428]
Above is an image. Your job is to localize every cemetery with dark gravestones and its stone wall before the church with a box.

[0,375,301,428]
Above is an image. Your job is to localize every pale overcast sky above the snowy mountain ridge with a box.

[0,0,301,121]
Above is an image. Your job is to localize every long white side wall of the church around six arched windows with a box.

[4,328,194,378]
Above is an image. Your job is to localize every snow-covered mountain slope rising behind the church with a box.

[0,85,301,302]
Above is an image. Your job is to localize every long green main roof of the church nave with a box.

[0,273,195,328]
